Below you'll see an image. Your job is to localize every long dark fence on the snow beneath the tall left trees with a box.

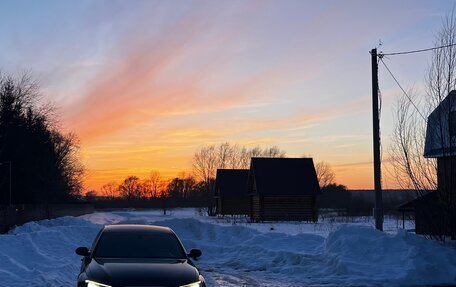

[0,203,94,233]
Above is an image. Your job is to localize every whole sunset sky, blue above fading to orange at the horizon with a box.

[0,0,454,189]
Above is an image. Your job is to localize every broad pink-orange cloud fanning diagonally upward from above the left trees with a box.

[65,4,280,141]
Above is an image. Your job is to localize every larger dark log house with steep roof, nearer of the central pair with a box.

[249,158,321,222]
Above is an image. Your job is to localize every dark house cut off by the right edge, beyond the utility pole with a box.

[399,91,456,235]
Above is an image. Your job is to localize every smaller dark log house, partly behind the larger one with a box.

[214,169,250,215]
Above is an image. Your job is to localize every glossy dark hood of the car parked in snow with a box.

[86,258,199,287]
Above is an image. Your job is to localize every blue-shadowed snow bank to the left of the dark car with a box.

[0,217,100,286]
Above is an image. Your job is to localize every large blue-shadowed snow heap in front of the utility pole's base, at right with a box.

[325,226,456,286]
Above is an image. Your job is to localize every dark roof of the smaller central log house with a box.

[215,169,249,197]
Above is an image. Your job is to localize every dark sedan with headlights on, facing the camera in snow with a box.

[76,225,206,287]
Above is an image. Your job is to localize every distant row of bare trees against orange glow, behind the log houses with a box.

[91,142,346,206]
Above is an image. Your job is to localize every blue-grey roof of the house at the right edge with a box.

[424,91,456,158]
